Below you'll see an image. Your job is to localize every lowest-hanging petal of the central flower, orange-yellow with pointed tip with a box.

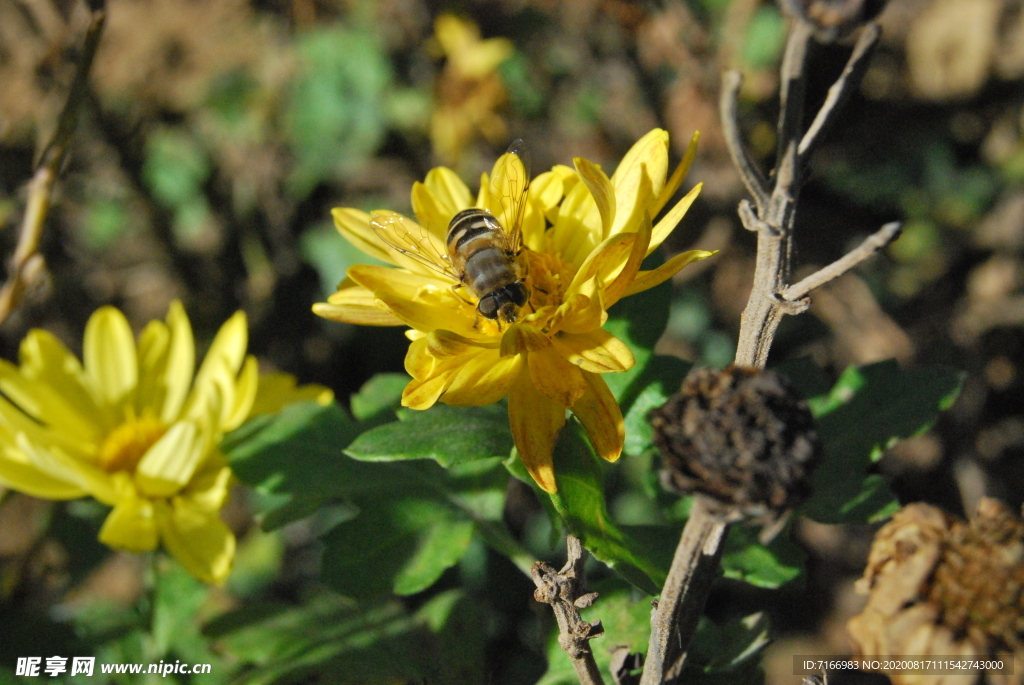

[509,370,565,494]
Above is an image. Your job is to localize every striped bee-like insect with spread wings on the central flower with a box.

[370,140,529,326]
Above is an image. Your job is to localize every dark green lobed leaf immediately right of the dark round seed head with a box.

[801,360,964,523]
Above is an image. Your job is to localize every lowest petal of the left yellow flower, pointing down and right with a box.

[157,498,236,585]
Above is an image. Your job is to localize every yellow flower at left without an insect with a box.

[0,302,331,584]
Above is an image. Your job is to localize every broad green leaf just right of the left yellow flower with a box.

[221,401,366,530]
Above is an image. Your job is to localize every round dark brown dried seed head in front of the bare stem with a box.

[648,367,821,522]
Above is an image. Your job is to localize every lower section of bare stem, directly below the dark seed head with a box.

[640,497,728,685]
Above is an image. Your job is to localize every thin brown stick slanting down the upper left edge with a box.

[0,2,106,324]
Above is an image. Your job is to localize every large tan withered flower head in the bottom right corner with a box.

[847,499,1024,685]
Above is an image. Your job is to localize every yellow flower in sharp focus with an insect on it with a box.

[313,129,713,493]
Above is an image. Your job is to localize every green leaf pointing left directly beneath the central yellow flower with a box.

[346,404,513,468]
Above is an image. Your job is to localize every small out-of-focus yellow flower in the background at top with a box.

[430,14,514,165]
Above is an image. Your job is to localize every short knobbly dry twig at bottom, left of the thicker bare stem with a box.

[531,534,604,685]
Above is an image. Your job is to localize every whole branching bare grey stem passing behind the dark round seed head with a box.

[640,15,900,685]
